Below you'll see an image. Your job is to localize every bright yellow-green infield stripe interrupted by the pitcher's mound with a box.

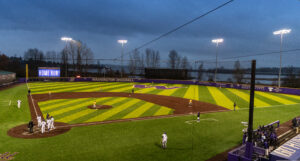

[58,97,111,122]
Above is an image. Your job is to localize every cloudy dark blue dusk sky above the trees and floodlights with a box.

[0,0,300,66]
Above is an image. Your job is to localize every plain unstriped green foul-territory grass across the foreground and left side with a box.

[0,85,300,161]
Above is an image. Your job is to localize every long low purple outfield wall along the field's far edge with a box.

[19,77,300,95]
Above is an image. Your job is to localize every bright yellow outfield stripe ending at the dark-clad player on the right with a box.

[207,87,239,110]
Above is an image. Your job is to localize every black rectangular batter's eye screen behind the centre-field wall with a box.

[145,68,188,80]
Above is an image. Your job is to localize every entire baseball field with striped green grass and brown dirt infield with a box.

[0,82,300,161]
